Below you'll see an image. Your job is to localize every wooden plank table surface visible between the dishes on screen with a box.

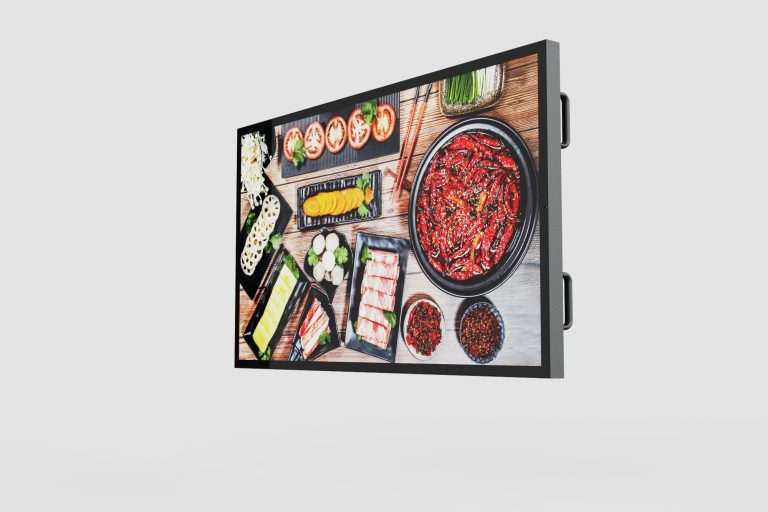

[239,55,541,366]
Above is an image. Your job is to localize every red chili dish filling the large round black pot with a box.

[416,131,521,281]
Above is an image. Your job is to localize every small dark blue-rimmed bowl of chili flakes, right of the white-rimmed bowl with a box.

[459,302,504,364]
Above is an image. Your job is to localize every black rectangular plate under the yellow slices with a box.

[296,171,382,231]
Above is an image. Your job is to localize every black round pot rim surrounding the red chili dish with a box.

[408,117,538,297]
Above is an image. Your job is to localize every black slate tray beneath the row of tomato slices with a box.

[275,92,400,178]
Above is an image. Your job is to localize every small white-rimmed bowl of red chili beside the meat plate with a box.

[403,299,445,361]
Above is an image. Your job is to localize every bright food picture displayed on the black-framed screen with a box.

[235,52,546,369]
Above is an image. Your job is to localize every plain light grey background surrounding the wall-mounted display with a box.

[0,1,768,511]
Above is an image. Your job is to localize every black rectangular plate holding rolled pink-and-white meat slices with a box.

[344,233,410,363]
